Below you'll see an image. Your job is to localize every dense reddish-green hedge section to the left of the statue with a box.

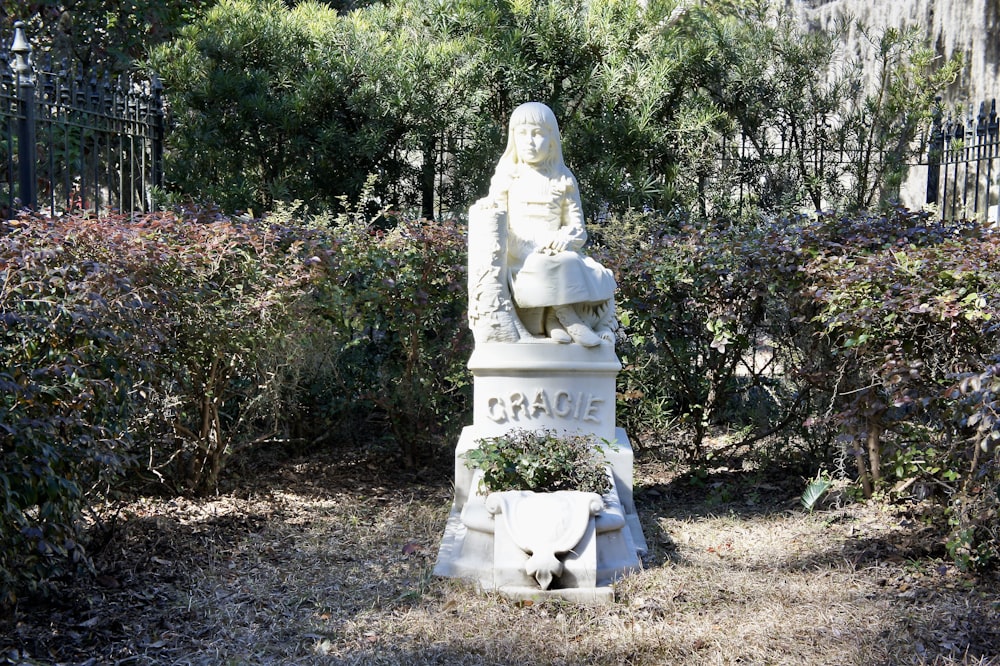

[0,212,471,602]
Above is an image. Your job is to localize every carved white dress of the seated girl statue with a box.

[507,170,615,308]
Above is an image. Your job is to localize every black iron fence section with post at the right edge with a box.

[927,99,1000,221]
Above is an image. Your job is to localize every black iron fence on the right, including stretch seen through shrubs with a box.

[708,99,1000,222]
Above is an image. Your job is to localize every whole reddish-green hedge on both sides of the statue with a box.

[0,210,1000,602]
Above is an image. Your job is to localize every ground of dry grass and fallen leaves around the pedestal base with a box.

[0,440,1000,665]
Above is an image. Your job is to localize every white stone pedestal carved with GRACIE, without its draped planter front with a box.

[434,340,646,602]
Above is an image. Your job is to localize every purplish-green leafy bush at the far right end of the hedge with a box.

[811,222,1000,567]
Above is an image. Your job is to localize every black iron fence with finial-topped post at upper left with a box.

[0,22,163,216]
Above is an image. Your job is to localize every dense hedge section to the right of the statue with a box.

[599,209,1000,565]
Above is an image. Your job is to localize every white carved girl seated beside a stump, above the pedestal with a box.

[469,102,616,347]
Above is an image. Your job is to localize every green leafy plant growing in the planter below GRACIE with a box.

[465,429,611,495]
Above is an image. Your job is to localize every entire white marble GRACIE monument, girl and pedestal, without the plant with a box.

[434,103,646,603]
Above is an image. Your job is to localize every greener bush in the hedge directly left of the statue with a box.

[312,206,472,465]
